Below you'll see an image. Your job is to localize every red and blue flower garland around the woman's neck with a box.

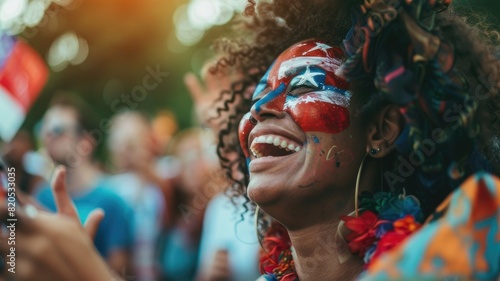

[259,191,423,281]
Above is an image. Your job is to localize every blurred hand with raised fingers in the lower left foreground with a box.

[0,166,119,281]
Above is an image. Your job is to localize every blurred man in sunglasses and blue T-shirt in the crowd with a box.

[35,96,133,273]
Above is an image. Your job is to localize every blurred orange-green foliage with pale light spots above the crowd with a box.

[0,0,500,158]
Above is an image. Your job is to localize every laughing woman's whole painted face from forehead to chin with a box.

[238,39,364,217]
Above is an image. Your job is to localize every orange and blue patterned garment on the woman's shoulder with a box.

[360,173,500,281]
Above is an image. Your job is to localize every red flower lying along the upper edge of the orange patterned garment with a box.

[367,215,421,267]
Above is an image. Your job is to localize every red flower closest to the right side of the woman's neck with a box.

[340,211,377,257]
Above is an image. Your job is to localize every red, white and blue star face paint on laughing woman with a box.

[248,40,351,134]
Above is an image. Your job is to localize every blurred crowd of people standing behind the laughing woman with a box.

[1,57,259,281]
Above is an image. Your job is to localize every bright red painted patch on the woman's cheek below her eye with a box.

[287,95,349,134]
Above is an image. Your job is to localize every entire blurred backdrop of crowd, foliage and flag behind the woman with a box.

[0,0,500,281]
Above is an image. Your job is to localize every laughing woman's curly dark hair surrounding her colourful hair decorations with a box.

[213,0,500,216]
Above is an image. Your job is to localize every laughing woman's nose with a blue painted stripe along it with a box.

[250,83,286,122]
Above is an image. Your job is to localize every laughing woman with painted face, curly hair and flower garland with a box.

[213,0,500,281]
